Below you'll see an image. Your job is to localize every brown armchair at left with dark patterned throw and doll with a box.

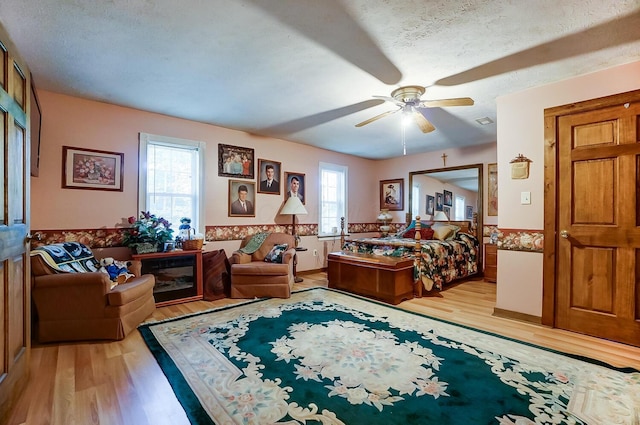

[31,243,156,342]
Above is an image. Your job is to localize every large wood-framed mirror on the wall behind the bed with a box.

[407,164,484,264]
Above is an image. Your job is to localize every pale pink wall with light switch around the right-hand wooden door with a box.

[496,62,640,316]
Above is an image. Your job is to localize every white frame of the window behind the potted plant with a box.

[138,132,206,235]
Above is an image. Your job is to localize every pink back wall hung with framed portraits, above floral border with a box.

[31,91,496,271]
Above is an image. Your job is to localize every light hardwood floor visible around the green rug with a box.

[9,273,640,425]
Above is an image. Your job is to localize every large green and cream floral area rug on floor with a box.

[140,288,640,425]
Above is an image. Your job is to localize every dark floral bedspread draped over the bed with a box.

[342,233,479,291]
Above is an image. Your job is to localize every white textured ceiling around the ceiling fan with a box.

[0,0,640,158]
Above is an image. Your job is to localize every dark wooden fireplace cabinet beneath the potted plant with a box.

[132,249,203,307]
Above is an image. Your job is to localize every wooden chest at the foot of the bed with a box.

[327,252,414,304]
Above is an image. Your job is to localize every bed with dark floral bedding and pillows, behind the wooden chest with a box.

[342,217,479,296]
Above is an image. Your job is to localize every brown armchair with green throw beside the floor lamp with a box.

[229,233,296,298]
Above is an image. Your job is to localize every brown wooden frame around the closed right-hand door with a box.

[542,90,640,327]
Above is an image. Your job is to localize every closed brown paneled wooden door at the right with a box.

[543,91,640,346]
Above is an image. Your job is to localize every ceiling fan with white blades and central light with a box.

[356,86,473,133]
